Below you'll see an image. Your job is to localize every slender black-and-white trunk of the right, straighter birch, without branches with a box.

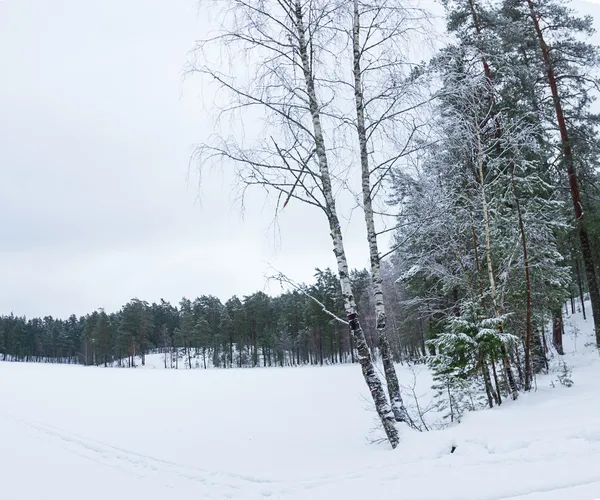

[352,0,408,422]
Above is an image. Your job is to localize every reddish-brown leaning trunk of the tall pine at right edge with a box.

[527,0,600,349]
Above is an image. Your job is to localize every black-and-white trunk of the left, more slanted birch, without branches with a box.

[294,2,399,448]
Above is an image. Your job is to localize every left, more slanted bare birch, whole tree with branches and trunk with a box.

[192,0,399,448]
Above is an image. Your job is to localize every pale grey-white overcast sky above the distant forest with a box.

[0,0,600,317]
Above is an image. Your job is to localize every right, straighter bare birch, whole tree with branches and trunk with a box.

[351,0,432,422]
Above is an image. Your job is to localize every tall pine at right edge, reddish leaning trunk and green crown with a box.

[503,0,600,348]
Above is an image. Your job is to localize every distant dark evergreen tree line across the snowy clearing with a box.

[0,269,410,368]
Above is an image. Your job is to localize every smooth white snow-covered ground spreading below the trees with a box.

[0,300,600,500]
